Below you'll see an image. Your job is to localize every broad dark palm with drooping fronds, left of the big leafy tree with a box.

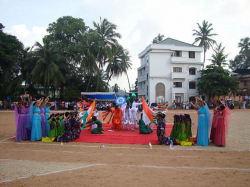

[31,38,66,94]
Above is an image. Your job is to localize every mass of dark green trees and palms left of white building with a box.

[0,16,132,101]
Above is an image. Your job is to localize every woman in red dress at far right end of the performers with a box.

[214,101,231,147]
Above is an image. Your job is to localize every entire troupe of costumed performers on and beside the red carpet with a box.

[14,96,230,146]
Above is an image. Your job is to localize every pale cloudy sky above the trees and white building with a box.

[0,0,250,91]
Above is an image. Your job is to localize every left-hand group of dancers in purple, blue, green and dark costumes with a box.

[14,96,81,142]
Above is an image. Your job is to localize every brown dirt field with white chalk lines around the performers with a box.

[0,109,250,187]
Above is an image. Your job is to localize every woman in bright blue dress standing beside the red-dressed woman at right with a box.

[192,97,211,146]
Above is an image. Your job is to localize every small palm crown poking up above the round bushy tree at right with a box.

[209,43,228,67]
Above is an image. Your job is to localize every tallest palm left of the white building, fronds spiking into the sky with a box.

[93,18,121,91]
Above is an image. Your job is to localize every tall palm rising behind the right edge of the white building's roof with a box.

[193,20,218,63]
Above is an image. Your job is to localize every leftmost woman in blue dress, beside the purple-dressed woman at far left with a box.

[30,99,43,141]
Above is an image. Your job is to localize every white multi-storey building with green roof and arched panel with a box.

[137,38,204,104]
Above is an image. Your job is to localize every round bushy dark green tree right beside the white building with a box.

[197,65,239,100]
